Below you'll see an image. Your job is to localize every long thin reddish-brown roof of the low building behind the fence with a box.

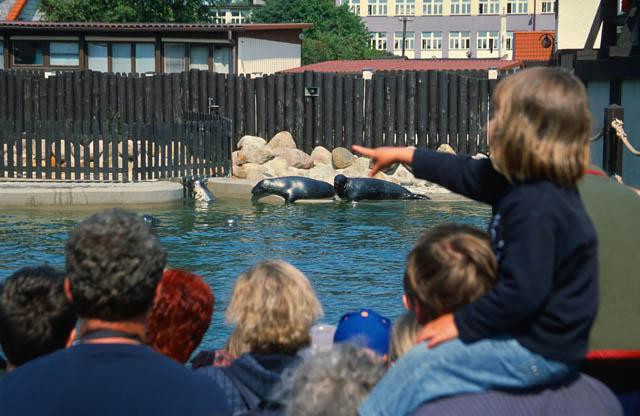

[0,21,312,32]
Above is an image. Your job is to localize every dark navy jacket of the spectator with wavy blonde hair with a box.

[196,353,298,414]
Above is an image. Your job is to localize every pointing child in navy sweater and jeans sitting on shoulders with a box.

[354,68,598,416]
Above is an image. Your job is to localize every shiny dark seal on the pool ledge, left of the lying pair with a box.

[251,176,335,202]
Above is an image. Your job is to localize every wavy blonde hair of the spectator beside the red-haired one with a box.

[226,260,322,354]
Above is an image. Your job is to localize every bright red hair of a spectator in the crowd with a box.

[147,269,215,364]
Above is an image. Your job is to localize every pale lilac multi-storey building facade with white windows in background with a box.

[336,0,557,59]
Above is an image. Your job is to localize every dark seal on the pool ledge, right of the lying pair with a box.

[333,175,430,201]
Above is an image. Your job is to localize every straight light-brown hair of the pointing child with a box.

[490,67,591,187]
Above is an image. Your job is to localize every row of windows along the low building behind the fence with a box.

[0,40,231,74]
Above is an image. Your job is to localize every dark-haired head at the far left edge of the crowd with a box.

[0,266,77,366]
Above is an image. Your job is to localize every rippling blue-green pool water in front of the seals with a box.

[0,200,490,348]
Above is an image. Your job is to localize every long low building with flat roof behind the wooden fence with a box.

[0,21,311,74]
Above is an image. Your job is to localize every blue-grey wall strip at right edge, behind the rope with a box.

[622,80,640,187]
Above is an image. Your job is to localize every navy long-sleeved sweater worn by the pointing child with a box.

[413,150,598,363]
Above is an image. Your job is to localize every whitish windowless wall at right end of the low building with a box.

[238,37,302,74]
